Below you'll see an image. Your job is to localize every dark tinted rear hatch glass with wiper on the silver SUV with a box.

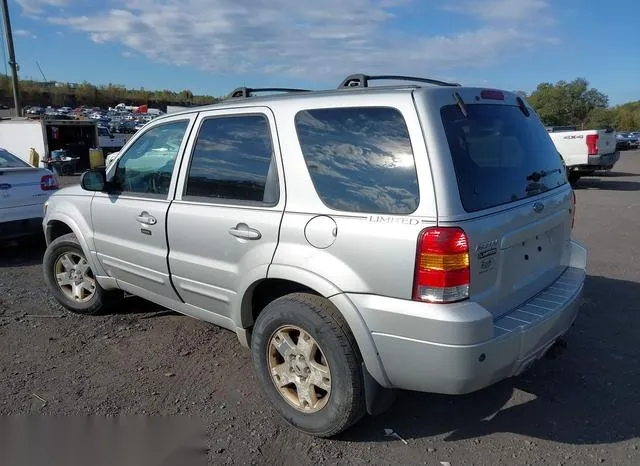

[441,104,567,212]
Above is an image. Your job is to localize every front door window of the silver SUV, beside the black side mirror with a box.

[115,120,189,195]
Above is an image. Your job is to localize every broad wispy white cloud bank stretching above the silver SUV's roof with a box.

[19,0,551,81]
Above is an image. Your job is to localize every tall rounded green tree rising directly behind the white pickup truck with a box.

[528,78,609,128]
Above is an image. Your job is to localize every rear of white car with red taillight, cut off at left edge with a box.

[0,149,57,222]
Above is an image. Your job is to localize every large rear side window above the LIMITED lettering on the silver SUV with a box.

[295,107,419,214]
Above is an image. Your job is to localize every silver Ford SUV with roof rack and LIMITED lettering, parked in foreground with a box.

[43,75,587,436]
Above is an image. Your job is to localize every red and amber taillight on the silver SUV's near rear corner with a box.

[413,227,470,303]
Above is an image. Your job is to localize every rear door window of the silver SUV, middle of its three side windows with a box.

[185,115,278,204]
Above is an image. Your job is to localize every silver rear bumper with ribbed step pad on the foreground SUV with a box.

[349,245,586,394]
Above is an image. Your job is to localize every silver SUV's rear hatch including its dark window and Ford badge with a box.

[438,88,574,316]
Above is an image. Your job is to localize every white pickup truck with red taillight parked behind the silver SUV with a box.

[547,126,620,184]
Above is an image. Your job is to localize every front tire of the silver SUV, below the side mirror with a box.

[42,233,123,315]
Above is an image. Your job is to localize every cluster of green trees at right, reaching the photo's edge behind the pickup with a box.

[526,78,640,131]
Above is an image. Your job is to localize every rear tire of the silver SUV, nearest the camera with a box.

[251,293,366,437]
